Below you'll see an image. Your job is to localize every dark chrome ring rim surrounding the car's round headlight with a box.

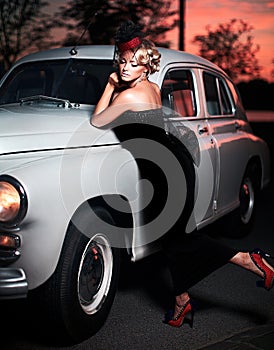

[0,175,28,228]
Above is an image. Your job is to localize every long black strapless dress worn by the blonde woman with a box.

[108,109,237,295]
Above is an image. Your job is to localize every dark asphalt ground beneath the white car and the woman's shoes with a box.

[0,124,274,350]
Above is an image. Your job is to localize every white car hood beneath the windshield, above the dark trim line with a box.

[0,104,118,155]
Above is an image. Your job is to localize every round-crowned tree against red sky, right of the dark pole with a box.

[193,19,261,79]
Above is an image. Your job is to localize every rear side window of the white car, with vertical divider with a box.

[203,72,233,115]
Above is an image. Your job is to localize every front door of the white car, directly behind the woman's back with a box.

[161,68,218,227]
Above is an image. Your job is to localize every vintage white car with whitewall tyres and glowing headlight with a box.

[0,46,270,342]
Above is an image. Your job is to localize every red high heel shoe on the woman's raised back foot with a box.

[249,248,274,290]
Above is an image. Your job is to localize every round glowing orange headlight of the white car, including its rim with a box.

[0,175,27,226]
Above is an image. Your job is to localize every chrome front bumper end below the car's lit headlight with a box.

[0,267,28,299]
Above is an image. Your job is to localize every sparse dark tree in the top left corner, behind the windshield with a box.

[0,0,57,70]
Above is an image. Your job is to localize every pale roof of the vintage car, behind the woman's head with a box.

[15,45,225,74]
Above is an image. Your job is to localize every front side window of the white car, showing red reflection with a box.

[161,69,197,117]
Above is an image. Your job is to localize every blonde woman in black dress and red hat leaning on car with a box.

[91,21,274,327]
